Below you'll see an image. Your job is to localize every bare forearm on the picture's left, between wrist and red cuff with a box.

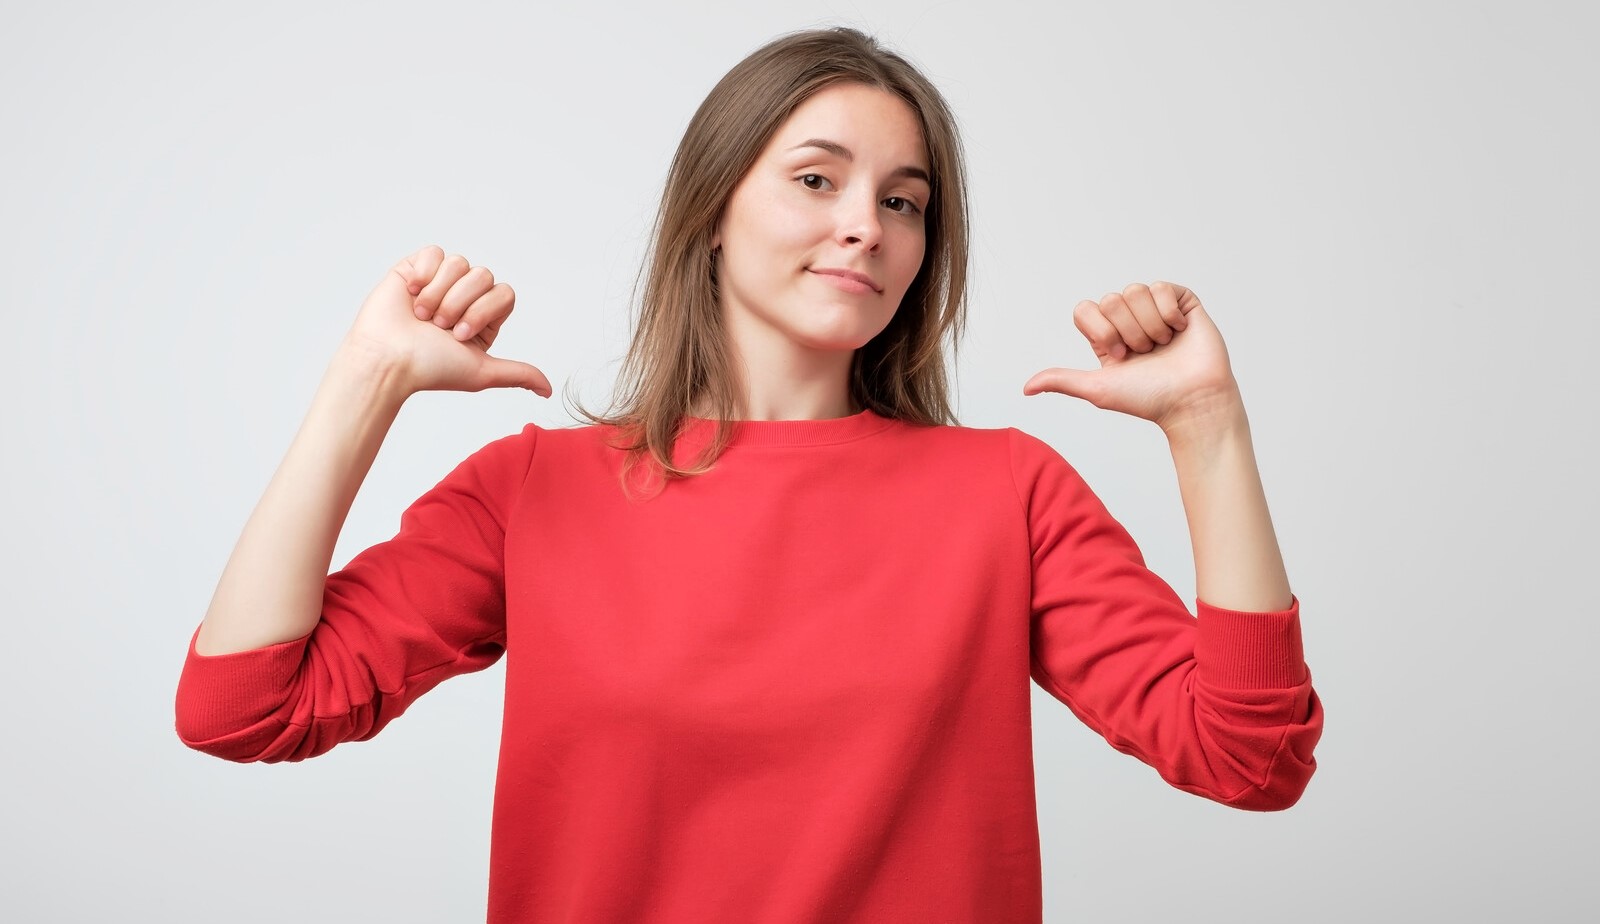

[195,344,405,655]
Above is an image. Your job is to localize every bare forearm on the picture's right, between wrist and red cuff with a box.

[1166,395,1291,612]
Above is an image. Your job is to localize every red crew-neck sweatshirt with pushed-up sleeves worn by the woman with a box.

[178,411,1322,924]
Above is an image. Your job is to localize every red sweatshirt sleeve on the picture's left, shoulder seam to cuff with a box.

[176,425,538,761]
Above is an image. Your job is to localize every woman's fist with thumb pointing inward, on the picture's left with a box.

[346,245,550,398]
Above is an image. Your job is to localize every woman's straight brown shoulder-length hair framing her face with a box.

[578,27,966,478]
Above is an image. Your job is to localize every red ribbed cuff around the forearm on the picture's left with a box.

[176,628,310,743]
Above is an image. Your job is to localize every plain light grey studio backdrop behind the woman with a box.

[0,0,1600,922]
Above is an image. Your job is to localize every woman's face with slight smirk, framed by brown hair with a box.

[712,83,931,363]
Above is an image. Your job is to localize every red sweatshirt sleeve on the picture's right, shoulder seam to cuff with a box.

[1011,430,1323,810]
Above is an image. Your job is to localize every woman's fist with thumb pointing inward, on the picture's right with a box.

[1022,283,1238,433]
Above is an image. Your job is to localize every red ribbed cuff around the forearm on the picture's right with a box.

[1195,596,1307,689]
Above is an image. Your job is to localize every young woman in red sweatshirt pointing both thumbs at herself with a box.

[178,30,1322,922]
